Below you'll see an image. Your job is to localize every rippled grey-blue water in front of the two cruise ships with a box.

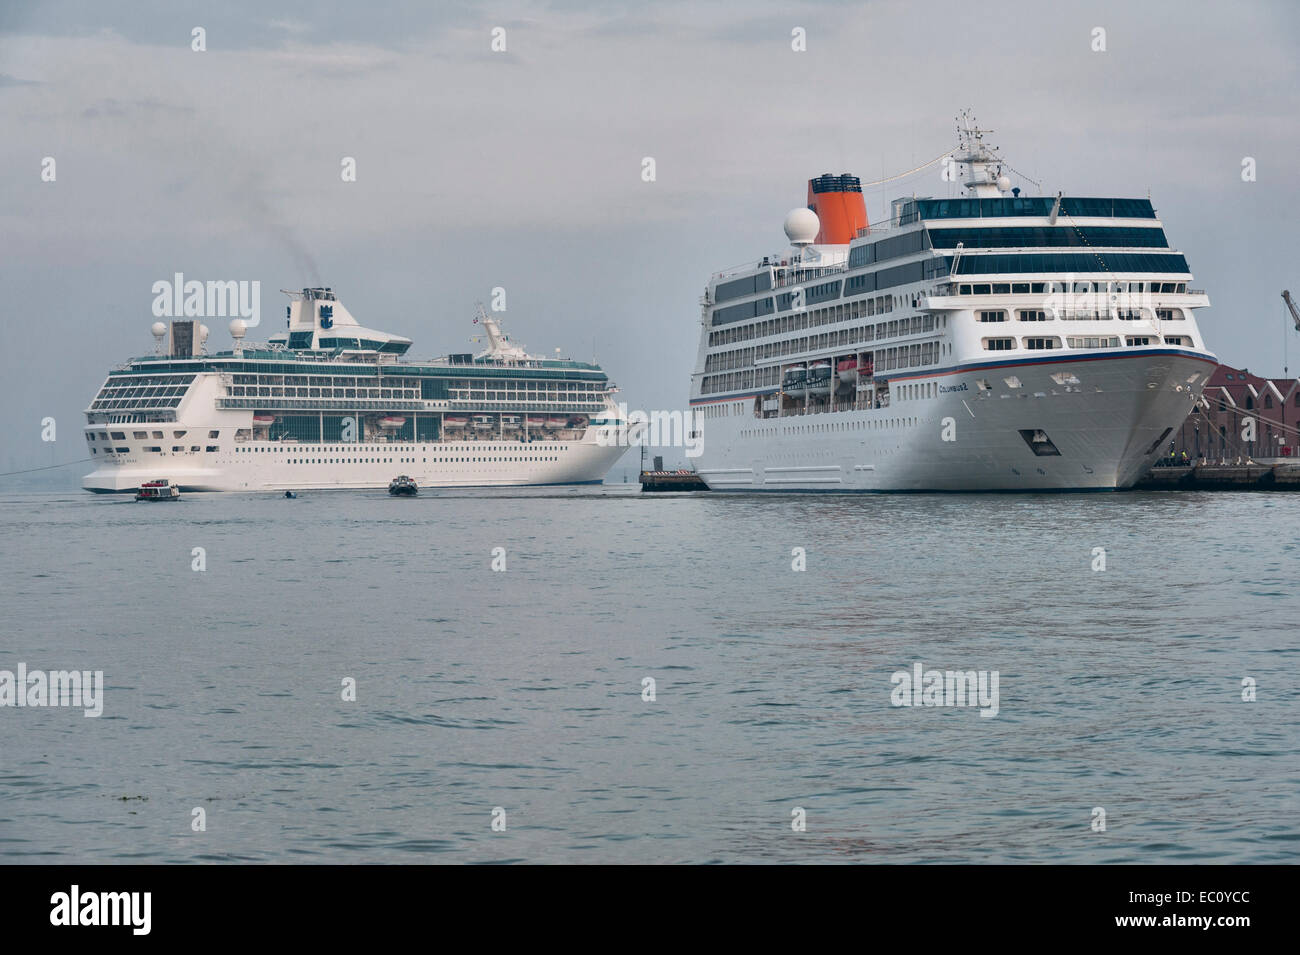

[0,486,1300,863]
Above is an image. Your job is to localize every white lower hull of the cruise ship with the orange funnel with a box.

[698,350,1216,492]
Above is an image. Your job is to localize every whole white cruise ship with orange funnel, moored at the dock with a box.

[690,114,1217,491]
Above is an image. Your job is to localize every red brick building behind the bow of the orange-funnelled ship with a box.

[1165,365,1300,464]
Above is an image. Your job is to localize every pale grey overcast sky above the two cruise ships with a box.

[0,0,1300,477]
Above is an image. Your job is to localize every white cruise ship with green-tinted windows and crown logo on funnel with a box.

[82,288,627,491]
